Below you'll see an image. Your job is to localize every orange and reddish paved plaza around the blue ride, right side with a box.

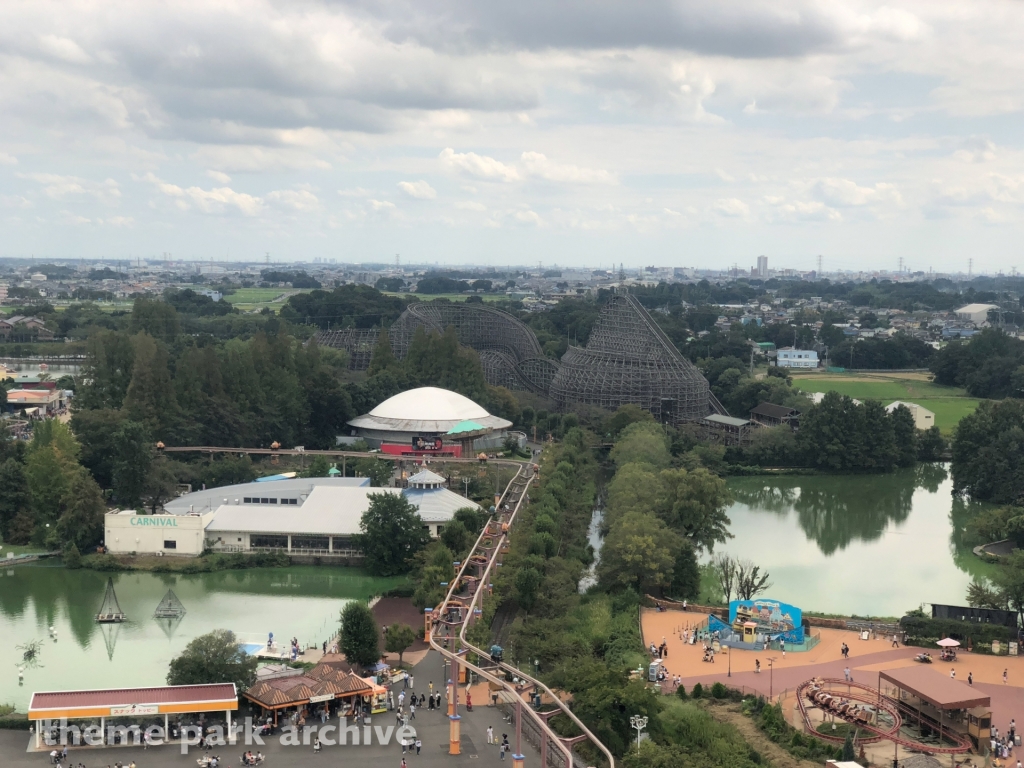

[641,608,1024,732]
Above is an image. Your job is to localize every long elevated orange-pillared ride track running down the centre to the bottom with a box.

[429,465,615,768]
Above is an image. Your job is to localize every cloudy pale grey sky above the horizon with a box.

[0,0,1024,273]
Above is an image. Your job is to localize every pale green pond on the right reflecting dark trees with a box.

[716,464,992,616]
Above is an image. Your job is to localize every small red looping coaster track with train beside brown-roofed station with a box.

[797,678,972,755]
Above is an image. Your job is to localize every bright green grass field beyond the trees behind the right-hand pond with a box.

[793,374,980,434]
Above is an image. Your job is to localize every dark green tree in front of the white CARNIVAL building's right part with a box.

[355,493,430,575]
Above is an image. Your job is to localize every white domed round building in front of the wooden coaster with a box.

[348,387,512,453]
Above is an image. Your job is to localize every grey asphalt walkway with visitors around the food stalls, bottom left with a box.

[0,651,540,768]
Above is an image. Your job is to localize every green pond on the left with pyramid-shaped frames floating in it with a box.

[0,561,401,712]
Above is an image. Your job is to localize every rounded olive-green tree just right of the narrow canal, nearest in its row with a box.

[597,512,682,593]
